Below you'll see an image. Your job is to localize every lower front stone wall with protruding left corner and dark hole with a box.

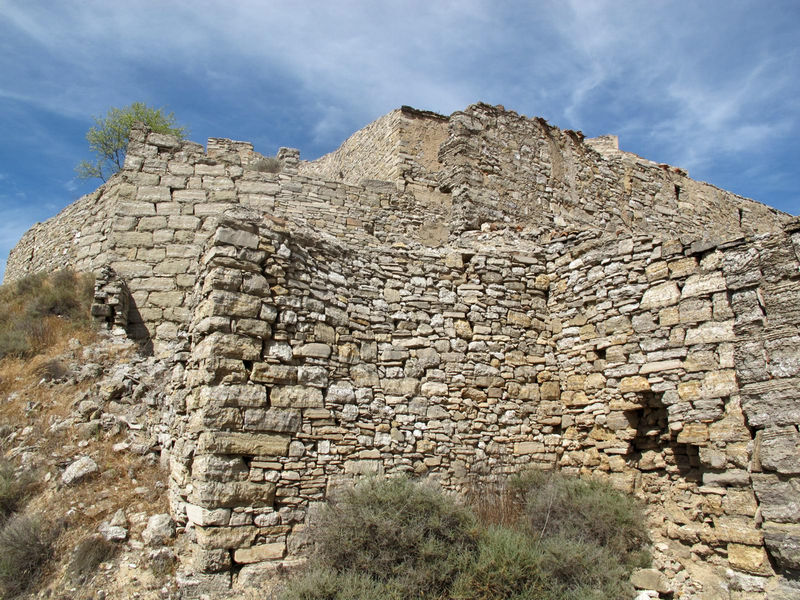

[166,204,800,598]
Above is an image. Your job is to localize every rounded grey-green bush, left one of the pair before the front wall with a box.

[286,478,477,598]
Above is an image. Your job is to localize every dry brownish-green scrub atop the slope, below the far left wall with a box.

[0,270,94,360]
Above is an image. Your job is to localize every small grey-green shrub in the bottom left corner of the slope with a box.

[0,515,54,598]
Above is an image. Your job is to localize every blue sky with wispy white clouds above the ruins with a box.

[0,0,800,282]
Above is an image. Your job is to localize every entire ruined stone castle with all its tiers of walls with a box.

[6,104,800,599]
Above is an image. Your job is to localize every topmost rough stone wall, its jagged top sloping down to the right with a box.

[439,104,786,241]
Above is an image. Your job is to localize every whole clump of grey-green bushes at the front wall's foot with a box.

[281,472,649,600]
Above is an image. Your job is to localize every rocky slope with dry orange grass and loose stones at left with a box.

[0,332,186,600]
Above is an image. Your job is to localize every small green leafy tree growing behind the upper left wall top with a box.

[75,102,186,181]
